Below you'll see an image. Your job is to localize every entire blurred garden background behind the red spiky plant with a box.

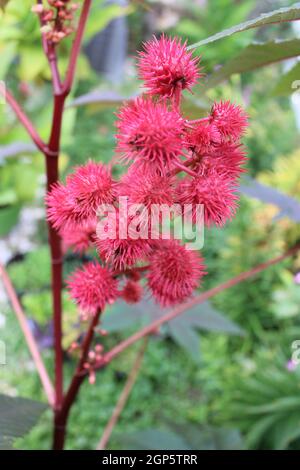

[0,0,300,449]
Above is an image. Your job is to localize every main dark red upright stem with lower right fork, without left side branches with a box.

[46,0,93,450]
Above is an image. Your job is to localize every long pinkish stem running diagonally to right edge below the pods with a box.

[95,244,300,369]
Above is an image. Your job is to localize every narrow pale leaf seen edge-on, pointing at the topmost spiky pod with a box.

[189,3,300,49]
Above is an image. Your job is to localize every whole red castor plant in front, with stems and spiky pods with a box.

[0,0,300,449]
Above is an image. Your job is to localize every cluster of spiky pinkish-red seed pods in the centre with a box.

[47,36,247,324]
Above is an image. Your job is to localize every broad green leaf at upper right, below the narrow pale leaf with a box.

[205,39,300,88]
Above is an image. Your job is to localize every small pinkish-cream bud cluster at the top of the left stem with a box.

[32,0,79,44]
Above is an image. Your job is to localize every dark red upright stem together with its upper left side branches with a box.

[0,0,94,449]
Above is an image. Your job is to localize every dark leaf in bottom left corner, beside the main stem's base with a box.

[0,394,46,450]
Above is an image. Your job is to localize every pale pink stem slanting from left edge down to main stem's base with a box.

[0,264,55,407]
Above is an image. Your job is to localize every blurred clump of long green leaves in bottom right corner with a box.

[224,348,300,450]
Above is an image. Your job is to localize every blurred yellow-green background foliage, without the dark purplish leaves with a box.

[0,0,300,449]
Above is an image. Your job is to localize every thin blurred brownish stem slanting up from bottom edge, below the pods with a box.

[97,337,148,450]
